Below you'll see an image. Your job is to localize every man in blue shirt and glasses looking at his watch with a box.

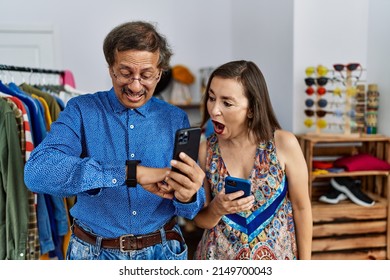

[25,21,205,259]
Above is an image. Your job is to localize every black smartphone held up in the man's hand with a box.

[172,127,201,174]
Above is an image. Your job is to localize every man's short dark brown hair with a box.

[103,21,173,70]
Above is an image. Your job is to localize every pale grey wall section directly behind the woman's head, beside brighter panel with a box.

[232,0,294,130]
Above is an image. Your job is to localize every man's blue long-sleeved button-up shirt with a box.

[25,89,205,237]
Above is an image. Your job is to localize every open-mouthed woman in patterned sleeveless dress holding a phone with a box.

[194,61,312,259]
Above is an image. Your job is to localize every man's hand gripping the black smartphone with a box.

[163,153,205,203]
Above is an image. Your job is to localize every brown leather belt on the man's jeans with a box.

[72,218,184,252]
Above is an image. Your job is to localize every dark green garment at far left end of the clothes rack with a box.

[0,98,29,260]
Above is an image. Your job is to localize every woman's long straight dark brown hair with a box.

[201,60,281,142]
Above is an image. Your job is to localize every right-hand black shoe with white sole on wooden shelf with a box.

[330,177,375,207]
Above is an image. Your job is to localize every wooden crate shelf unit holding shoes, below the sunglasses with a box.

[297,134,390,260]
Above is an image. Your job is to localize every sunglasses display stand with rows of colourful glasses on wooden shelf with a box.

[304,63,368,138]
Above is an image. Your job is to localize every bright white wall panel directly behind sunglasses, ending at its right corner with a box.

[293,0,369,133]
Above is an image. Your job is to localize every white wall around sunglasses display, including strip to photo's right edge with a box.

[293,0,390,135]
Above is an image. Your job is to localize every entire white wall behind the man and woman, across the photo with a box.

[0,0,390,135]
